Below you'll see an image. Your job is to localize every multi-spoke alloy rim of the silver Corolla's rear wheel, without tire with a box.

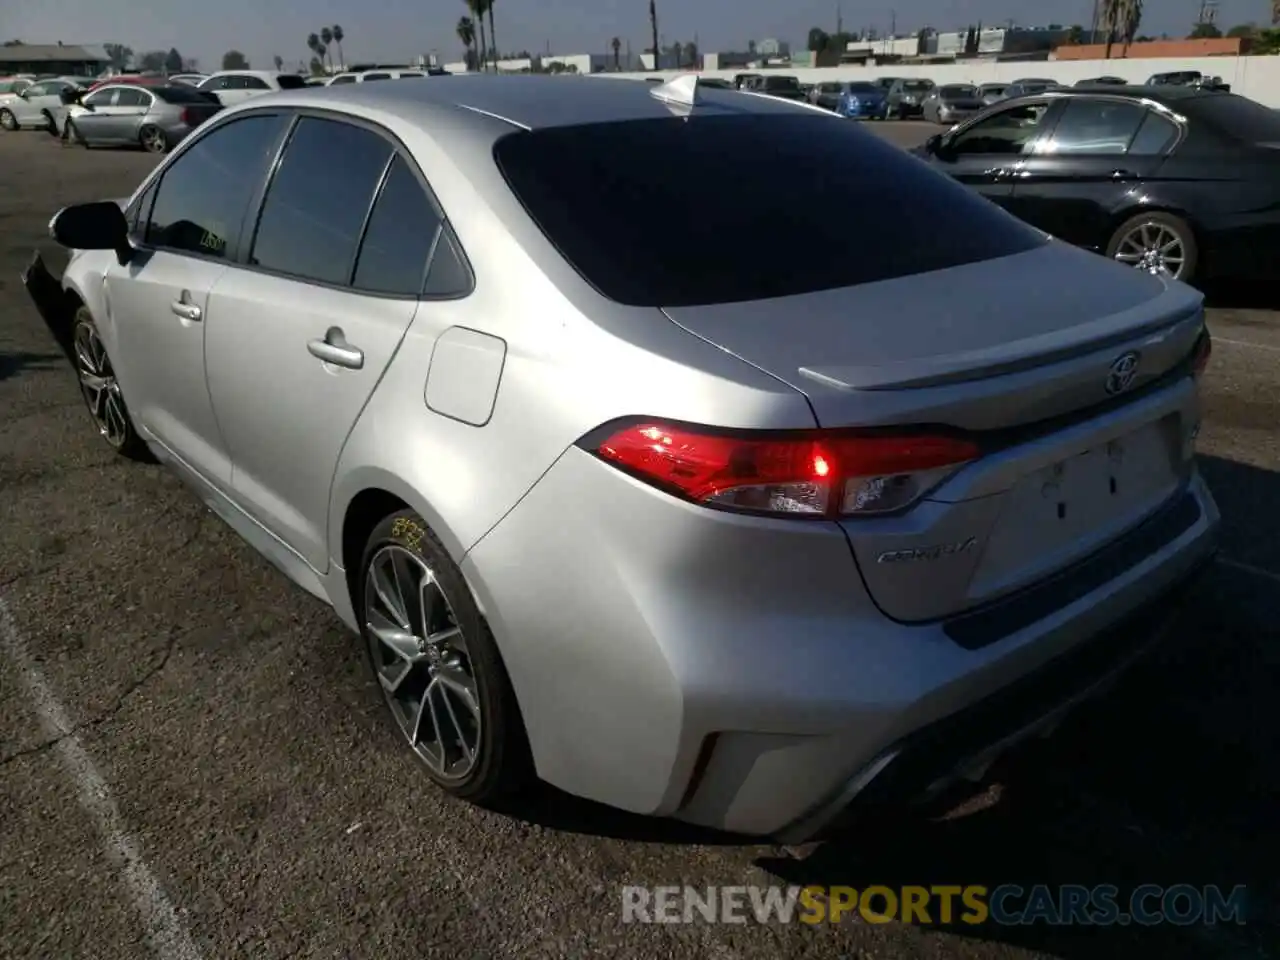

[364,544,484,782]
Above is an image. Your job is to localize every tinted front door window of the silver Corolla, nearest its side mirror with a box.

[146,116,284,257]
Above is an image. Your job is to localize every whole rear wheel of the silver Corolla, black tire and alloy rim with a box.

[353,509,532,806]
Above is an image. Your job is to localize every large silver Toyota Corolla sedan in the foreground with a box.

[26,76,1219,841]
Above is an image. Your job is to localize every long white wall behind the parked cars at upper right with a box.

[609,56,1280,108]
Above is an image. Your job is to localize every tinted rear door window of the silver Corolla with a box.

[251,116,392,284]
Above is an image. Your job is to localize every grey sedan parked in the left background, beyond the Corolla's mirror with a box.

[67,83,223,154]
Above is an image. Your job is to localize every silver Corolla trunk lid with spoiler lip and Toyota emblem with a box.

[666,243,1203,622]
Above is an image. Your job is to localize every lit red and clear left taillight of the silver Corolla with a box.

[582,421,980,517]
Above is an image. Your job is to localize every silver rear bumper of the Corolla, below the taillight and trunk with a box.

[462,448,1219,841]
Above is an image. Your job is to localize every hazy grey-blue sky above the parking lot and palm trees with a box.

[0,0,1270,69]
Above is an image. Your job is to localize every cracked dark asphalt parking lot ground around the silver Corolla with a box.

[0,124,1280,960]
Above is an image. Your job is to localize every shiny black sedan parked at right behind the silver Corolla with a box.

[915,86,1280,280]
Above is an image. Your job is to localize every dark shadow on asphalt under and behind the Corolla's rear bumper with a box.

[759,458,1280,960]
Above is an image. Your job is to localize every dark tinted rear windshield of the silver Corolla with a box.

[494,113,1047,306]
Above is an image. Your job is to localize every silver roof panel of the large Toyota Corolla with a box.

[234,74,832,131]
